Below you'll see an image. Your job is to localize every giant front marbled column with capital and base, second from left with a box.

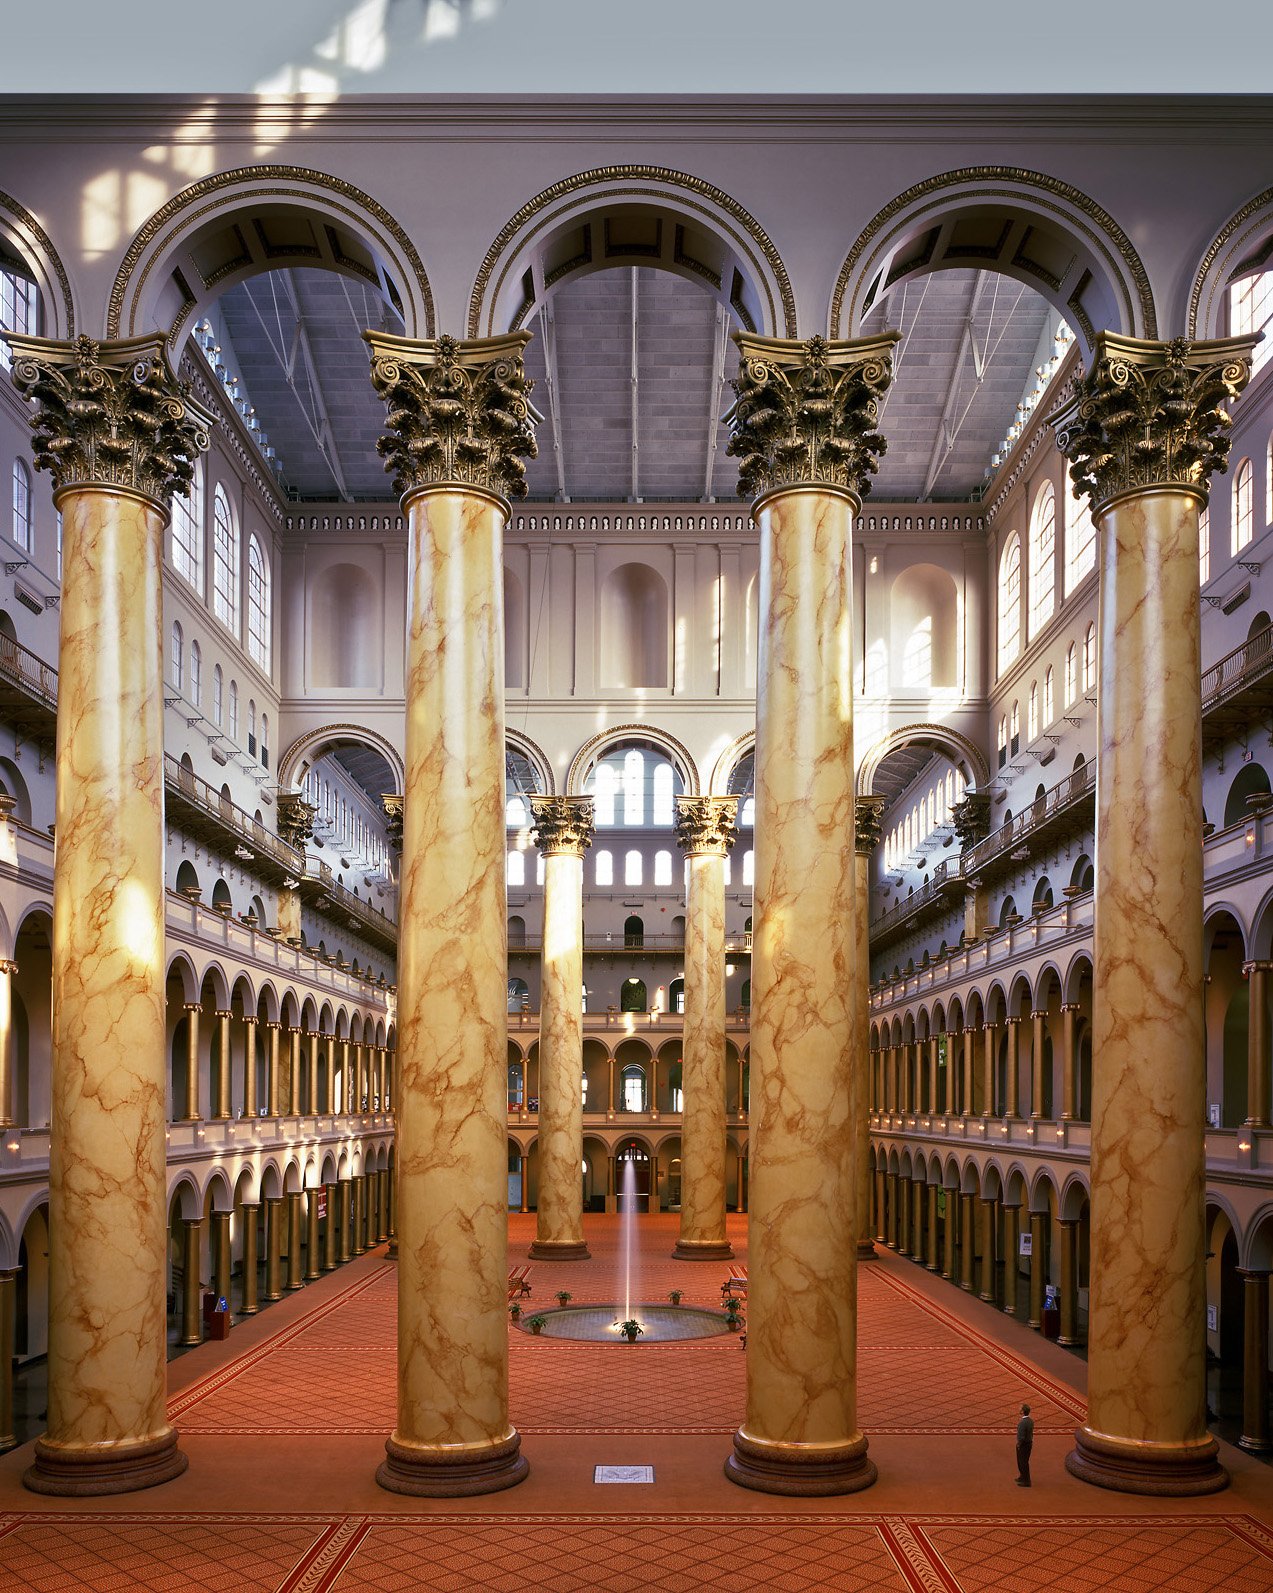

[366,323,537,1496]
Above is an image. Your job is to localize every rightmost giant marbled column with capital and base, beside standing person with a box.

[1053,333,1252,1494]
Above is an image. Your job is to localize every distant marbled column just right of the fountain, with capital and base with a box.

[672,797,738,1262]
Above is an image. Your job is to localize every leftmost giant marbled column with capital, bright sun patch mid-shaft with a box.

[8,335,209,1494]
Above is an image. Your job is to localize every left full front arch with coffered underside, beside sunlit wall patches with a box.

[107,166,435,355]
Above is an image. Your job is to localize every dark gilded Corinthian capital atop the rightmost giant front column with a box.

[1048,331,1259,513]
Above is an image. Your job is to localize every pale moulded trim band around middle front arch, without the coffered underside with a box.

[468,166,795,338]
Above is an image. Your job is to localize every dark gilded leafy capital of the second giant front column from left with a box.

[363,331,543,499]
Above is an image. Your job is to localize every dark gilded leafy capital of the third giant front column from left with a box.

[725,331,899,497]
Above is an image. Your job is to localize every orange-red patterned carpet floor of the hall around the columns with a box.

[0,1214,1273,1593]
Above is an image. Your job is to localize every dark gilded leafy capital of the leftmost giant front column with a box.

[6,335,212,510]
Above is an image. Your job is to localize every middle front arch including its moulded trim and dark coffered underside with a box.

[467,166,795,338]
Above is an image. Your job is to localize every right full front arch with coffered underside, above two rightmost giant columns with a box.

[828,166,1158,355]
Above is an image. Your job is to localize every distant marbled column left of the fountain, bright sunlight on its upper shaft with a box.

[529,797,595,1262]
